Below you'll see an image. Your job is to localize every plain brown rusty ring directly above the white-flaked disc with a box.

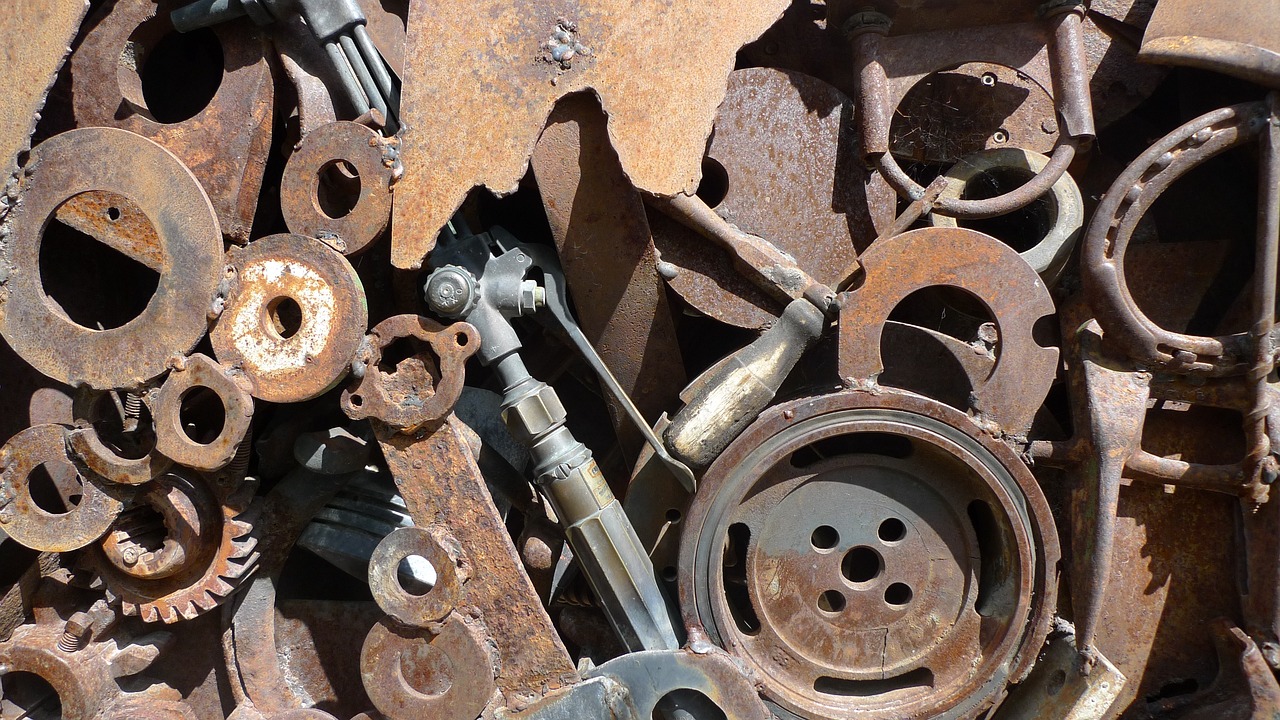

[280,122,393,255]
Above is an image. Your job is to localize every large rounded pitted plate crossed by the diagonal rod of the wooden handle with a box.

[650,68,896,328]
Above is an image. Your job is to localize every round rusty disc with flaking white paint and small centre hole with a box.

[209,234,369,402]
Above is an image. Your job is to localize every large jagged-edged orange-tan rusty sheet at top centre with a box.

[392,0,787,268]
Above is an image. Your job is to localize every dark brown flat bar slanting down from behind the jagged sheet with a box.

[532,96,685,451]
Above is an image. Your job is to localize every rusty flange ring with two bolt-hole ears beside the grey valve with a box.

[342,315,480,433]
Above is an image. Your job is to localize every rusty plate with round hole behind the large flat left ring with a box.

[70,0,275,242]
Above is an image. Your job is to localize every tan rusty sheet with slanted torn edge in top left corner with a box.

[0,0,88,184]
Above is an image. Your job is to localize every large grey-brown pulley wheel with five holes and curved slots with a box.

[680,392,1059,720]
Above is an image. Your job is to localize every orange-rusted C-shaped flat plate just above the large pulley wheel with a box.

[840,228,1059,433]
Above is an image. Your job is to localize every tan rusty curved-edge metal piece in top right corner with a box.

[1138,0,1280,87]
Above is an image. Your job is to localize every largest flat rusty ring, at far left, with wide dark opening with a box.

[0,128,223,388]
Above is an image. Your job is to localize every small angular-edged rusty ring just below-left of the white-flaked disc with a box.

[154,355,253,471]
